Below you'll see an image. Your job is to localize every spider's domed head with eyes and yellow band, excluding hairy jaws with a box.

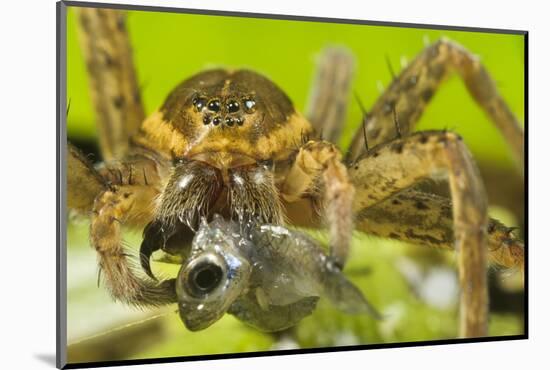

[138,69,312,168]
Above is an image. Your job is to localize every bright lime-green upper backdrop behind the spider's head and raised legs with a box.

[67,7,524,165]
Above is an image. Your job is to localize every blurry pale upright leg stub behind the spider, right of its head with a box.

[307,47,354,143]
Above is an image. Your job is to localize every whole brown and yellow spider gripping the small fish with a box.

[67,8,524,337]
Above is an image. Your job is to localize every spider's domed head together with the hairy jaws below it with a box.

[132,70,322,264]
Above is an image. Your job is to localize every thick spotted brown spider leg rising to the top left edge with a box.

[76,8,145,160]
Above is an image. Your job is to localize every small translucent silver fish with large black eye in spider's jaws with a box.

[176,215,380,332]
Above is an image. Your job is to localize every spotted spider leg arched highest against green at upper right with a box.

[346,39,524,168]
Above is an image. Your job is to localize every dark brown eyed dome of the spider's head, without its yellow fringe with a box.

[161,69,294,135]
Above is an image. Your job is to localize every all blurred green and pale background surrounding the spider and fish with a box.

[67,5,525,361]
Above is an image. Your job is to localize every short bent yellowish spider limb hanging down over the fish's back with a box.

[280,141,354,267]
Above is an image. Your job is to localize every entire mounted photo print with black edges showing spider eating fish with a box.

[58,2,527,368]
